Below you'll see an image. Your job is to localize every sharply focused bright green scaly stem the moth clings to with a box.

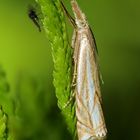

[36,0,75,134]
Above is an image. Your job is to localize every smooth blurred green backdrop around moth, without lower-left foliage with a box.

[0,0,140,140]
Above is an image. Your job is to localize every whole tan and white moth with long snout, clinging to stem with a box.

[63,0,107,140]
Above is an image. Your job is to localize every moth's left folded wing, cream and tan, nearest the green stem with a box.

[76,35,94,140]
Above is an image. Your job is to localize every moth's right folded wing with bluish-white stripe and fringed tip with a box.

[86,38,107,138]
